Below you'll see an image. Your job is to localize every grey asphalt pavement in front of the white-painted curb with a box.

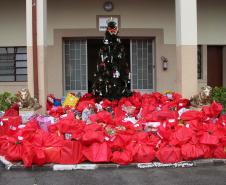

[0,165,226,185]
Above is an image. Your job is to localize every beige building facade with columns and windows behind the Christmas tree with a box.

[0,0,226,108]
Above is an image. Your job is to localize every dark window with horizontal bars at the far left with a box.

[0,47,27,82]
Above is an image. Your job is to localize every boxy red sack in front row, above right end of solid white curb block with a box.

[83,142,111,162]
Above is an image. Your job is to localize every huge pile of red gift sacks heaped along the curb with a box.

[0,93,226,167]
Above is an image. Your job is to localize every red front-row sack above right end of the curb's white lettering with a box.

[181,143,204,160]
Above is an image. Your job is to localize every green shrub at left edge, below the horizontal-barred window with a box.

[0,92,17,111]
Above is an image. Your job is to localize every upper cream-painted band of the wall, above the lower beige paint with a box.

[0,0,226,46]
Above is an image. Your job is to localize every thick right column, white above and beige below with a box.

[175,0,198,98]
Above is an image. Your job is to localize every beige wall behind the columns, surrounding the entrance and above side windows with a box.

[0,0,226,96]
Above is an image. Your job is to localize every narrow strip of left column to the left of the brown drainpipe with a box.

[26,0,34,97]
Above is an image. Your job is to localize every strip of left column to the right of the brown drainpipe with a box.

[37,0,47,111]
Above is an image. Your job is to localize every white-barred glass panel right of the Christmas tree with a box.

[131,39,154,90]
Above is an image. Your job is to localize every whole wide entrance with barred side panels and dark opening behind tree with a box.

[63,38,155,94]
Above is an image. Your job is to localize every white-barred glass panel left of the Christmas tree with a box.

[64,39,88,91]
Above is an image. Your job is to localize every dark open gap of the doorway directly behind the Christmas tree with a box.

[87,38,130,93]
